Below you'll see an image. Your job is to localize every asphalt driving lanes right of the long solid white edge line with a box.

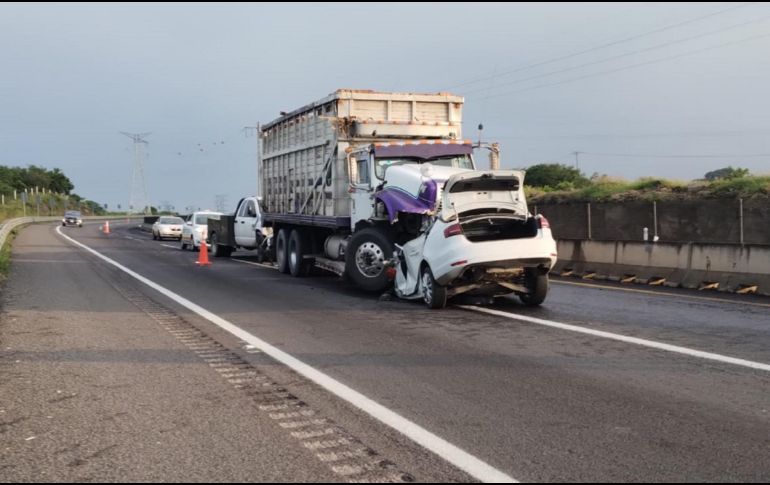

[25,222,770,481]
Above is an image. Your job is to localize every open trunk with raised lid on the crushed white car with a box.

[441,170,538,242]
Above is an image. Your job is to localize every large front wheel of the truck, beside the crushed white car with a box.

[345,227,393,292]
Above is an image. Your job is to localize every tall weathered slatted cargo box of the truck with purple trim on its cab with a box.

[259,89,463,227]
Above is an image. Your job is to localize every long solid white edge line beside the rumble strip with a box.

[56,227,516,483]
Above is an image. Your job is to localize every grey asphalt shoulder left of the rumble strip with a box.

[0,222,358,483]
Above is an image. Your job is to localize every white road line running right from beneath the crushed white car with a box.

[457,305,770,371]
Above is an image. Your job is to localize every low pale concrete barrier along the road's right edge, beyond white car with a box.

[555,239,770,295]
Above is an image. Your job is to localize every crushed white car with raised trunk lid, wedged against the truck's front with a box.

[392,170,557,309]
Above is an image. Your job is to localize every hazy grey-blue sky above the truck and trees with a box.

[0,2,770,209]
